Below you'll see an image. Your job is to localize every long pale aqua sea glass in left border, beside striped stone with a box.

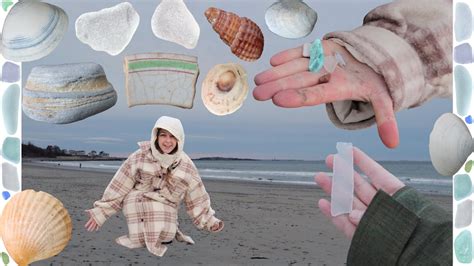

[2,84,20,135]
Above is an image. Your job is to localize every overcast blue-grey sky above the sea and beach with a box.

[22,0,452,160]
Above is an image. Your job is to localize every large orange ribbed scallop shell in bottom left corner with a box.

[0,190,72,265]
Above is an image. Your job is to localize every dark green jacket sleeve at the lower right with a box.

[347,187,452,265]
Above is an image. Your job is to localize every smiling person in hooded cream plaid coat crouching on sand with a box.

[85,116,224,257]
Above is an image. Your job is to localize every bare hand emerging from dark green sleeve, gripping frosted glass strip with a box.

[315,148,405,239]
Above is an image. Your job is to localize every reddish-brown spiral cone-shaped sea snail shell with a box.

[205,7,264,61]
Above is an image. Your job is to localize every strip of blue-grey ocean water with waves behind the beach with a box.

[38,160,452,195]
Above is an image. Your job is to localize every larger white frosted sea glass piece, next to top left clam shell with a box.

[76,2,140,55]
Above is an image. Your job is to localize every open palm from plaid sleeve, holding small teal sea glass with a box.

[253,40,399,148]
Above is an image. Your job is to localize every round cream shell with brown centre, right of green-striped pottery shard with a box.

[201,63,249,115]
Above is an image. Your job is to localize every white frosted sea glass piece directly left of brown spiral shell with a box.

[151,0,201,49]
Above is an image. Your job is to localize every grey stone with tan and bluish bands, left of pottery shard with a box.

[23,63,117,124]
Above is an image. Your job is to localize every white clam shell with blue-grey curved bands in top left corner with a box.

[2,1,68,62]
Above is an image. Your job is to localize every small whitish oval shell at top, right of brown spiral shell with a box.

[265,0,318,39]
